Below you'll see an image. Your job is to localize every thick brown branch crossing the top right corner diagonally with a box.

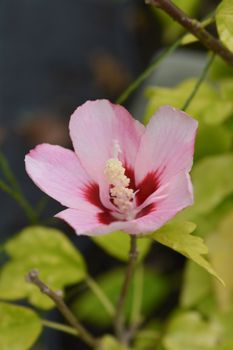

[145,0,233,66]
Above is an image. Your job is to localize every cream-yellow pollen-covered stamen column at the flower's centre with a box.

[104,158,135,219]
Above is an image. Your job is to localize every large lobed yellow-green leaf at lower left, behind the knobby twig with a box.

[0,226,86,309]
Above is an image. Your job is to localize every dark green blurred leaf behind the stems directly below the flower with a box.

[73,269,170,327]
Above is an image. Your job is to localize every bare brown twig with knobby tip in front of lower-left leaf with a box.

[26,269,97,348]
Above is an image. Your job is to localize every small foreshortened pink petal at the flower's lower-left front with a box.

[56,208,132,236]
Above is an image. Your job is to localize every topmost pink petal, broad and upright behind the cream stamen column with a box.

[70,100,145,207]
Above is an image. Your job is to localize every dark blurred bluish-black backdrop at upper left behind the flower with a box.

[0,0,160,238]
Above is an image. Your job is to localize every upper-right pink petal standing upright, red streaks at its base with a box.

[135,106,198,187]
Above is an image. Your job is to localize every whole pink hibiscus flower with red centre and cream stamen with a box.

[25,100,197,235]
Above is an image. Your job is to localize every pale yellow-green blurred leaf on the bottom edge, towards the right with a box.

[163,312,223,350]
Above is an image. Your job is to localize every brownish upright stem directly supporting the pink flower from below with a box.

[115,236,138,341]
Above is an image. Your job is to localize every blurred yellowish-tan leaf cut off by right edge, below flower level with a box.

[207,210,233,310]
